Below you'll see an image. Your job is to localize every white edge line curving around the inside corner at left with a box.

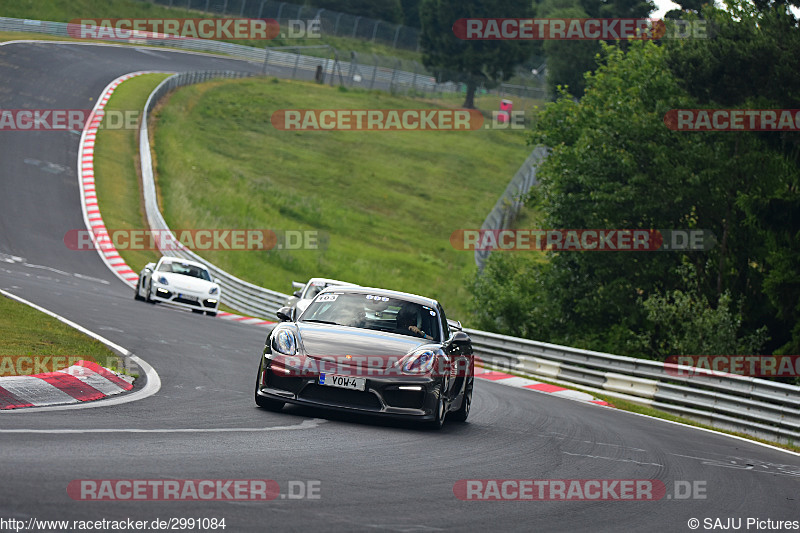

[0,289,161,414]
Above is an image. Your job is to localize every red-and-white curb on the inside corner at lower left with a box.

[0,361,133,410]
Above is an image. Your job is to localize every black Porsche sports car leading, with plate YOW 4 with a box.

[255,287,475,428]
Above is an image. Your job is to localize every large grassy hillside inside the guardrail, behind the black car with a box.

[151,78,530,322]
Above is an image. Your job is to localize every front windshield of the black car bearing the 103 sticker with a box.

[300,292,440,342]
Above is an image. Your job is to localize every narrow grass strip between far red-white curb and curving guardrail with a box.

[94,74,168,272]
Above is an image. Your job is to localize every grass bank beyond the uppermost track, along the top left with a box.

[0,0,421,62]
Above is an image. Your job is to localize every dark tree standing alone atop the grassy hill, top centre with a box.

[420,0,530,109]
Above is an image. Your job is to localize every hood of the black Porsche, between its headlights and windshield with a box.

[297,323,430,360]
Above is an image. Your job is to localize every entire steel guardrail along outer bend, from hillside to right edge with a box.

[140,72,800,442]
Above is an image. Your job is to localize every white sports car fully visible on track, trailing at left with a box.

[134,256,221,316]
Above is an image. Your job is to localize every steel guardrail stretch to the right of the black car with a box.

[465,329,800,442]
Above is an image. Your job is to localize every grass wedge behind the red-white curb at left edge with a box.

[0,295,125,370]
